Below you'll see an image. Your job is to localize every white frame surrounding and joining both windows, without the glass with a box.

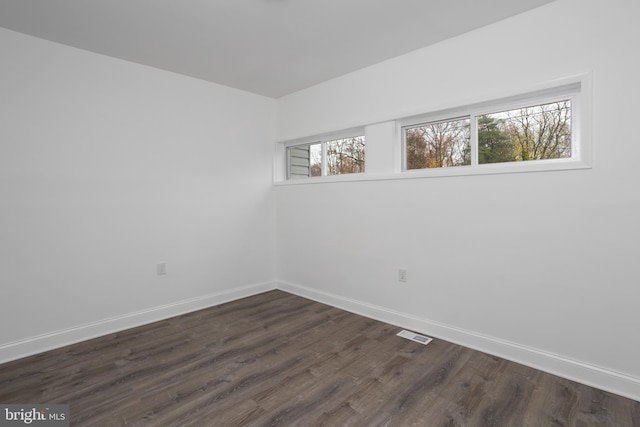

[273,73,592,185]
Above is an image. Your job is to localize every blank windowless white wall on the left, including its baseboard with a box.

[0,29,275,360]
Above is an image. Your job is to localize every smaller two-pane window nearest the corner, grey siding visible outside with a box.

[287,135,365,179]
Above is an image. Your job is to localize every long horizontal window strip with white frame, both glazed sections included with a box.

[273,74,592,185]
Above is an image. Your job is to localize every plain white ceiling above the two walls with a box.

[0,0,553,98]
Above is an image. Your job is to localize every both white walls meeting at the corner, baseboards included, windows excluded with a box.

[0,0,640,399]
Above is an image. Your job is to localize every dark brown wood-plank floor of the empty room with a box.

[0,291,640,427]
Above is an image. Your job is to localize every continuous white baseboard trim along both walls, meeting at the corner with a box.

[6,281,640,401]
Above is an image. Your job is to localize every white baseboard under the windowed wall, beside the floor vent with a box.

[277,281,640,401]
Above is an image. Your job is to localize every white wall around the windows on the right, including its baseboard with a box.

[276,0,640,399]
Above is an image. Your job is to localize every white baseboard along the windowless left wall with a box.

[0,282,276,363]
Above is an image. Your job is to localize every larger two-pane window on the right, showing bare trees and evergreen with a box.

[402,86,579,171]
